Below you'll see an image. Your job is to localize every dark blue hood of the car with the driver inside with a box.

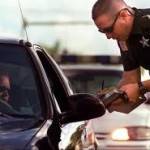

[0,117,38,150]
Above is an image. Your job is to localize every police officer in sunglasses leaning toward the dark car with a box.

[92,0,150,110]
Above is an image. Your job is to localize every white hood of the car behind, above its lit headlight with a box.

[92,104,150,133]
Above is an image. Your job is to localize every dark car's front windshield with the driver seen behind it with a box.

[0,44,41,116]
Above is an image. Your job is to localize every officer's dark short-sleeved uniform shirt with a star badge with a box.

[118,8,150,71]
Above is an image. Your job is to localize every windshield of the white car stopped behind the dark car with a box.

[64,69,122,94]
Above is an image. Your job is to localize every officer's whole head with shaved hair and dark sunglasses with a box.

[92,0,134,40]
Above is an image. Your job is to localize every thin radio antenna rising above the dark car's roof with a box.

[18,0,29,41]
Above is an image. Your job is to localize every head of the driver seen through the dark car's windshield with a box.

[0,73,10,102]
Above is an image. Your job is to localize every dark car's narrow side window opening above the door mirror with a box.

[37,49,71,111]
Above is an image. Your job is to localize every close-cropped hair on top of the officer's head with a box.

[92,0,129,20]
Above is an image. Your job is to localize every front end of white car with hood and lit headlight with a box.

[91,104,150,150]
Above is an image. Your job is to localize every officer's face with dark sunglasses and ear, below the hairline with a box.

[95,10,131,40]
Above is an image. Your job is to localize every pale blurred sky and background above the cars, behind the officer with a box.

[0,0,150,55]
